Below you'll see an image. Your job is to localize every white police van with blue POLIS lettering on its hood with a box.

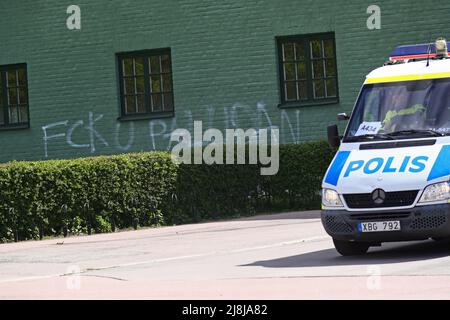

[322,38,450,255]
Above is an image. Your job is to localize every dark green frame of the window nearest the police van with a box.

[276,32,339,108]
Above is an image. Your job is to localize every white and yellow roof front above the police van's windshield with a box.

[364,59,450,84]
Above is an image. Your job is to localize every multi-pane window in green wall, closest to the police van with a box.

[277,33,338,105]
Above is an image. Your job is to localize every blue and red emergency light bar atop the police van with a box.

[389,38,450,61]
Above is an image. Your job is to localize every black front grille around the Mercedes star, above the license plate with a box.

[343,190,419,209]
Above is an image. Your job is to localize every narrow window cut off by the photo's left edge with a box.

[0,64,29,129]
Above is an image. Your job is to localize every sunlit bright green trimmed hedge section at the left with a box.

[0,152,177,241]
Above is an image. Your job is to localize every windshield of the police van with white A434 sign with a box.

[344,78,450,142]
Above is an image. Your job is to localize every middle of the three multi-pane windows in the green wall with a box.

[118,49,174,119]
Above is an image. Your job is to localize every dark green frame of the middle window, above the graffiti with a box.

[116,48,175,121]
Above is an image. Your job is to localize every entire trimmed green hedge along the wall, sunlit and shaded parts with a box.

[0,142,334,241]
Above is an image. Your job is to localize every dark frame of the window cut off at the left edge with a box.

[0,63,30,131]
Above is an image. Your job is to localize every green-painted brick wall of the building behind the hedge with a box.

[0,0,450,161]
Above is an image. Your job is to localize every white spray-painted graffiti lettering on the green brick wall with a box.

[42,102,300,158]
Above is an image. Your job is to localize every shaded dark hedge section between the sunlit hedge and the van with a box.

[171,141,334,222]
